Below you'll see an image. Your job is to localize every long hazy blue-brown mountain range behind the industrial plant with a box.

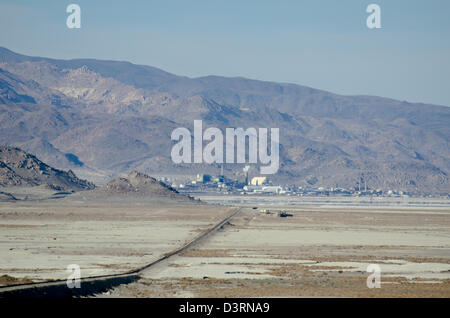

[0,47,450,194]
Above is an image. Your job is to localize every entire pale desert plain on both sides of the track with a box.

[0,189,450,297]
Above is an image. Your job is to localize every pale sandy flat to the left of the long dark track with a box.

[0,191,231,285]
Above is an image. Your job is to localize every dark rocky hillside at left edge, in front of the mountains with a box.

[0,146,94,191]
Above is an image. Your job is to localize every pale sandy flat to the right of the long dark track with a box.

[107,202,450,297]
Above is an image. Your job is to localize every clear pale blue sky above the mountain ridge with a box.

[0,0,450,106]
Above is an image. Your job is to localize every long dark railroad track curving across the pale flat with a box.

[0,208,242,298]
